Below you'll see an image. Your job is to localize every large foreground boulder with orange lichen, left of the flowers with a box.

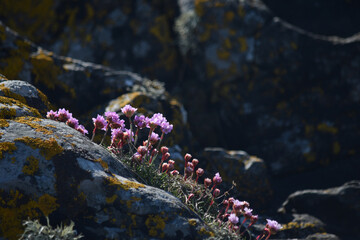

[0,80,212,239]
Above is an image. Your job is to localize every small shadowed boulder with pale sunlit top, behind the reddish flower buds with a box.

[200,148,272,209]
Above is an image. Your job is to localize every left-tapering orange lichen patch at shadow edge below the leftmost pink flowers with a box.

[14,137,64,160]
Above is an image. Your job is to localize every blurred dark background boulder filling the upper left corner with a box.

[0,0,179,79]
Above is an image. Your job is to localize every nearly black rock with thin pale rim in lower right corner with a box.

[280,181,360,239]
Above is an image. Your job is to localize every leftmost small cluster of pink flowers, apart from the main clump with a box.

[46,108,88,135]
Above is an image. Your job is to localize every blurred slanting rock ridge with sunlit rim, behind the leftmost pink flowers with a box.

[0,22,166,122]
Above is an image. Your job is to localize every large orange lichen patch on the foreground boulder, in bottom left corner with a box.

[0,190,59,240]
